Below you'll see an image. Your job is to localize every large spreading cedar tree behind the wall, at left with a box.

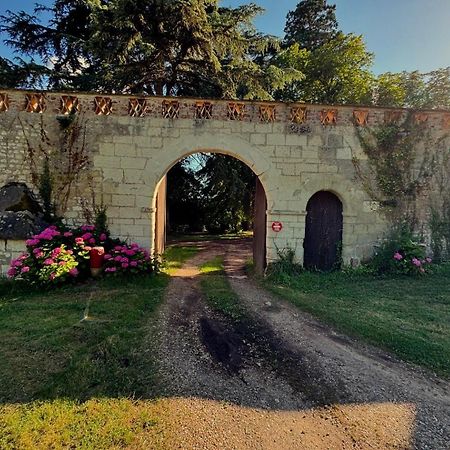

[1,0,295,98]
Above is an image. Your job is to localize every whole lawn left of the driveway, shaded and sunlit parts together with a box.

[0,248,195,450]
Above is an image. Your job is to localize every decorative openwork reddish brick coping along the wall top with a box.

[0,89,450,132]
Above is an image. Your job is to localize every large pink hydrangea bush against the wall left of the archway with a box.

[8,225,157,285]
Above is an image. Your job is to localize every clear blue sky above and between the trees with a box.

[0,0,450,73]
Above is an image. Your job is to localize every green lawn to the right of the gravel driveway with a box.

[263,265,450,378]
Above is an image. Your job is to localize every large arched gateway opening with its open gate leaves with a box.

[154,153,267,274]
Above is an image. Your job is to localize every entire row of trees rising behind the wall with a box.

[0,0,450,108]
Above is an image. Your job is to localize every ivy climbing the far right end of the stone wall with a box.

[353,112,450,260]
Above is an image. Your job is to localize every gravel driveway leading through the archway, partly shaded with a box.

[153,241,450,450]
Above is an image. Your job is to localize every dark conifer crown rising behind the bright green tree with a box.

[284,0,338,50]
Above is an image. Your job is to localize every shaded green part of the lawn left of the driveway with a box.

[0,274,167,403]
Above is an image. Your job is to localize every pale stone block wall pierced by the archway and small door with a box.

[0,91,450,263]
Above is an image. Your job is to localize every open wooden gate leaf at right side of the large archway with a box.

[253,177,267,275]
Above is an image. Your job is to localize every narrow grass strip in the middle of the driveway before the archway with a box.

[200,257,245,321]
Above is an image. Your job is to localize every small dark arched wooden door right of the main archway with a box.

[303,191,342,271]
